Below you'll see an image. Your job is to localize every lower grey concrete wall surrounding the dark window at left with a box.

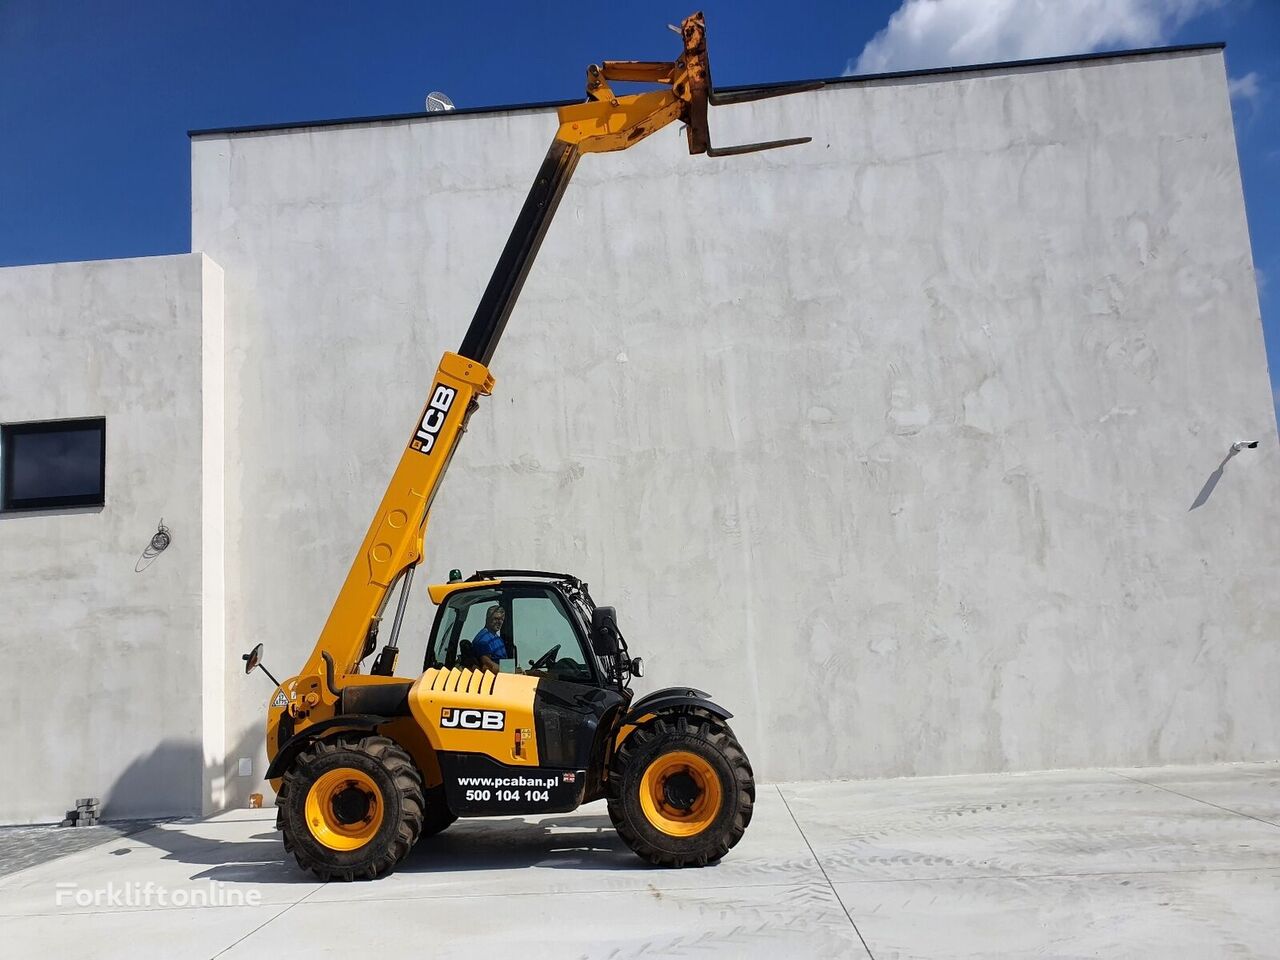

[0,255,225,823]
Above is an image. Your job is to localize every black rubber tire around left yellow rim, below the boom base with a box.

[275,735,424,881]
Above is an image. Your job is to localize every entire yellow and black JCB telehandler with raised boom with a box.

[244,13,817,881]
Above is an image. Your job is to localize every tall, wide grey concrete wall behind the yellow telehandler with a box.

[192,51,1280,797]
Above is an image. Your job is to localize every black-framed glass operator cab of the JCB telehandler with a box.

[422,570,641,686]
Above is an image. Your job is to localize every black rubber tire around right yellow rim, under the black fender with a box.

[608,714,755,867]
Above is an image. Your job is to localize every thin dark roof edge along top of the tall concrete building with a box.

[187,41,1226,137]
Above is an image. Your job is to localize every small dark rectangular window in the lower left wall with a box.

[0,417,106,509]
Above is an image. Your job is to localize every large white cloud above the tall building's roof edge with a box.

[845,0,1226,74]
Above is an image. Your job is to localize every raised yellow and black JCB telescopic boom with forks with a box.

[300,13,820,707]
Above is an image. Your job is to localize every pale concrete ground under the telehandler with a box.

[0,763,1280,960]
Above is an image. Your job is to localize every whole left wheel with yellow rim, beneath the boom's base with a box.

[275,736,424,881]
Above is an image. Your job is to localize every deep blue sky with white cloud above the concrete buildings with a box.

[0,0,1280,417]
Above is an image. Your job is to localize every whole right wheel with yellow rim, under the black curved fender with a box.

[609,716,755,867]
